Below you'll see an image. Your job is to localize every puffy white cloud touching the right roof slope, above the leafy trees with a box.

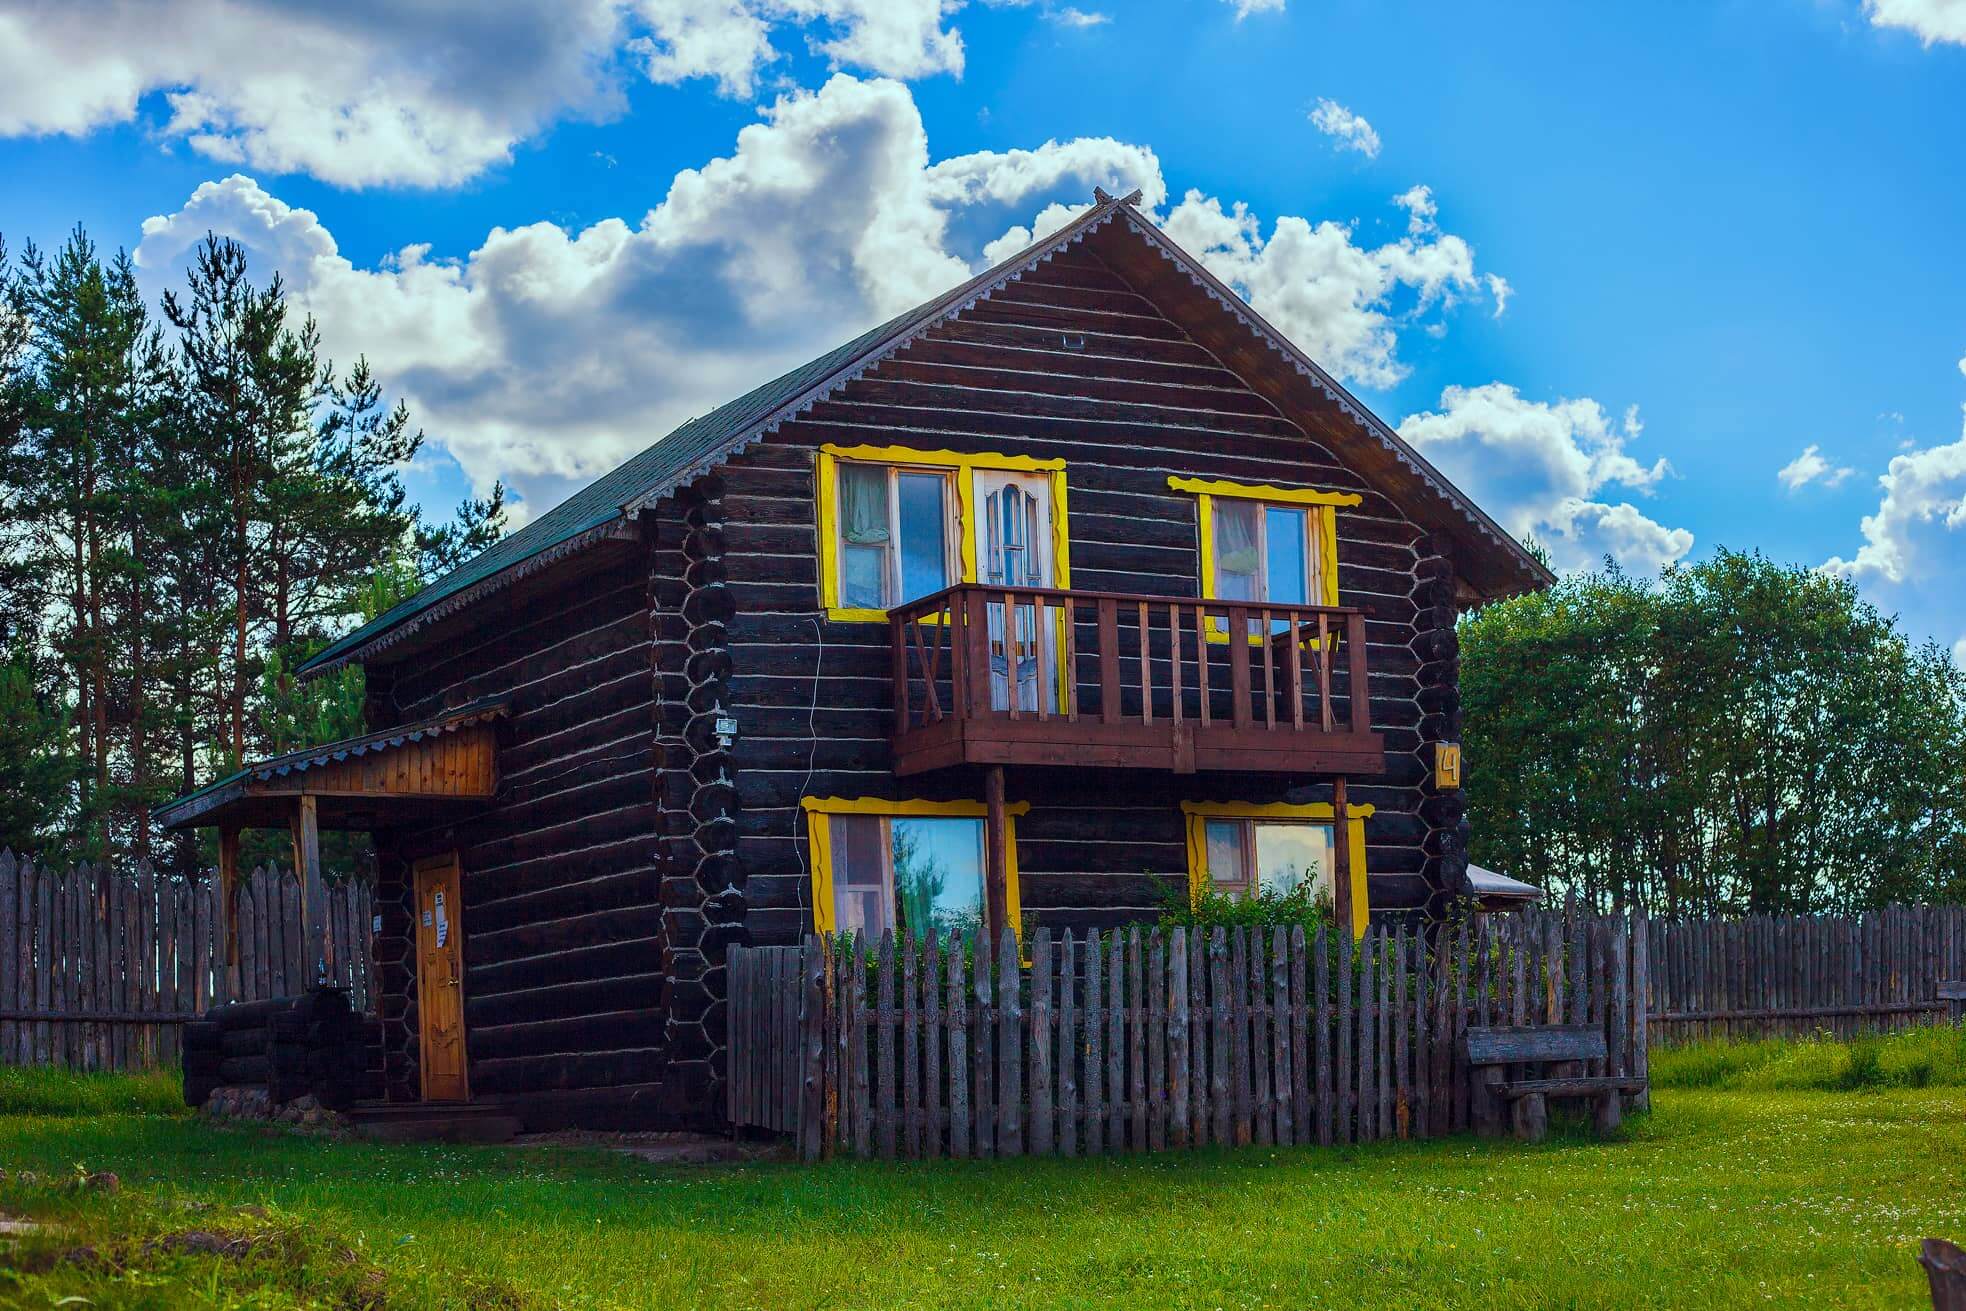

[1400,383,1693,572]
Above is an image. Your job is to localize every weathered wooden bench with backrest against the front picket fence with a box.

[1463,1024,1646,1142]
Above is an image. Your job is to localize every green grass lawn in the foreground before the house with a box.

[0,1087,1966,1311]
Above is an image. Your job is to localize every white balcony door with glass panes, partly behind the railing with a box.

[975,470,1062,712]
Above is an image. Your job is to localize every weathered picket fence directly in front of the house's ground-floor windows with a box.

[727,914,1648,1160]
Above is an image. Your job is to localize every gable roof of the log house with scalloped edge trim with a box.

[299,191,1551,678]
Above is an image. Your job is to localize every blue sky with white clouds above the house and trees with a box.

[0,0,1966,660]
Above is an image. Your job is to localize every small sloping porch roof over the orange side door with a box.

[151,698,511,829]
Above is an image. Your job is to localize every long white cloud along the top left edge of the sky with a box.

[0,0,963,187]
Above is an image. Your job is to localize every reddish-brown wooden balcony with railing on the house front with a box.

[889,584,1386,774]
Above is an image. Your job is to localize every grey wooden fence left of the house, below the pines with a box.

[0,851,374,1069]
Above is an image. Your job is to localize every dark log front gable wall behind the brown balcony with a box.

[722,248,1451,941]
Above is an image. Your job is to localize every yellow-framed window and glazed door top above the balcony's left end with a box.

[818,444,1071,619]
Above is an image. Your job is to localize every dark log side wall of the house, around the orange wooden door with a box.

[370,544,668,1126]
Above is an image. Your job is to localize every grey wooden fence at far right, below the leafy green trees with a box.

[1648,906,1966,1044]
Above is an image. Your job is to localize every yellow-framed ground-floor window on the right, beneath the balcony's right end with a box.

[1182,802,1372,934]
